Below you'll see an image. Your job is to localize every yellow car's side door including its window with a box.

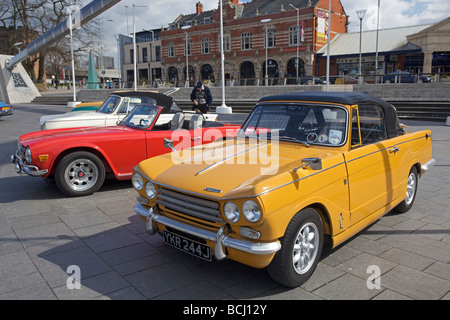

[345,103,402,225]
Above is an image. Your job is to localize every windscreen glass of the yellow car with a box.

[238,104,348,146]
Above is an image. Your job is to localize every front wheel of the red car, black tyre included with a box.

[55,151,105,197]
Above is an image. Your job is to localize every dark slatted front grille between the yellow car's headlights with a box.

[156,188,224,223]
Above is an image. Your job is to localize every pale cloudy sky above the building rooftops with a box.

[94,0,450,56]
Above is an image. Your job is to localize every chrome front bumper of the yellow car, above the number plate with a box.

[134,204,281,260]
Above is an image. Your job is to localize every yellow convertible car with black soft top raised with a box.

[132,92,435,287]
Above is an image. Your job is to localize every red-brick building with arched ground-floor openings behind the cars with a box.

[161,0,348,86]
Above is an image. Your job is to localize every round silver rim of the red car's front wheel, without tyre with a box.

[64,159,98,191]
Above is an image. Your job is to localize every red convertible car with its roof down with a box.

[11,104,240,196]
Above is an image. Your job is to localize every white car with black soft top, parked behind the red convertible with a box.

[39,91,207,130]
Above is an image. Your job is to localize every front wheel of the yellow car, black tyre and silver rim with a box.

[268,208,324,287]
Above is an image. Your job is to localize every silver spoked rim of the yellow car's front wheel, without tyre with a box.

[292,223,319,274]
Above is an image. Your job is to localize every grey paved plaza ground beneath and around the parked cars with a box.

[0,104,450,303]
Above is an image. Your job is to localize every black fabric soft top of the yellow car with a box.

[258,92,404,138]
